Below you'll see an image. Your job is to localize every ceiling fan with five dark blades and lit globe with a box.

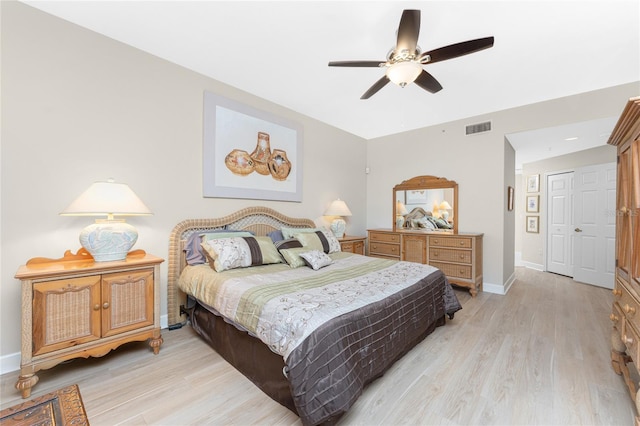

[329,9,493,99]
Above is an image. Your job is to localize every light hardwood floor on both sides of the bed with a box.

[0,268,634,426]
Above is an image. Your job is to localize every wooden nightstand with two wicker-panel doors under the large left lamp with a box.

[15,249,164,398]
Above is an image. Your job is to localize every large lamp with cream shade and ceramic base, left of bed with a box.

[60,179,152,262]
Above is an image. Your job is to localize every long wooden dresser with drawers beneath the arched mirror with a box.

[368,229,483,297]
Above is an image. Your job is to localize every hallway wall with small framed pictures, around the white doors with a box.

[521,145,624,270]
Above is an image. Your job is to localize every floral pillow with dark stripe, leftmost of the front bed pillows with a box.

[202,237,282,272]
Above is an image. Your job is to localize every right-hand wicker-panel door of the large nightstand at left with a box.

[102,269,154,337]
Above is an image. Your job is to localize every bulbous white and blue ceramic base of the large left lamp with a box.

[80,220,138,262]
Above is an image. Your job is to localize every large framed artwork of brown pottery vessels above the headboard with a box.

[202,92,303,202]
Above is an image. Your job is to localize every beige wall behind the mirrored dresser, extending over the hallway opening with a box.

[366,82,640,293]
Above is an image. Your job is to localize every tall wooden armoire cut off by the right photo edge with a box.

[608,97,640,425]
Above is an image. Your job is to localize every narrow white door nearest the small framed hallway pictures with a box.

[546,172,574,277]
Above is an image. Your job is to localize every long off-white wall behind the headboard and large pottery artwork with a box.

[0,2,366,372]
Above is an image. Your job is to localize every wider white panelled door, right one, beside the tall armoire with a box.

[573,163,616,288]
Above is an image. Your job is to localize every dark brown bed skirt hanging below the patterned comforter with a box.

[189,301,445,422]
